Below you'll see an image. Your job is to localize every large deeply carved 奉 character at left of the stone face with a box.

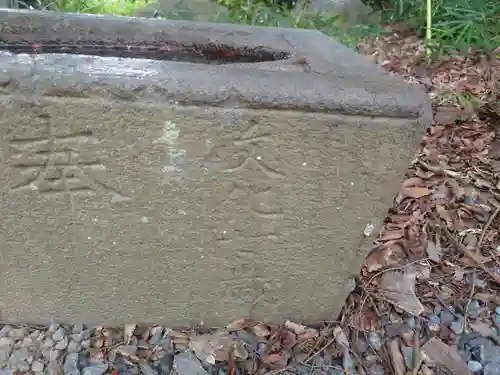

[5,115,131,209]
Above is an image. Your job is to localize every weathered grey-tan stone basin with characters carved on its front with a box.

[0,10,430,326]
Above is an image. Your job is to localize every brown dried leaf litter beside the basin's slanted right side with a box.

[344,28,500,330]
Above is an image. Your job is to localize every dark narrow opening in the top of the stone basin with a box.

[0,37,289,64]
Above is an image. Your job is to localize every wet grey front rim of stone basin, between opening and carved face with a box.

[0,52,426,118]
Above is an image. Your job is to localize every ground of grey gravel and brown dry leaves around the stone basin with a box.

[0,20,500,375]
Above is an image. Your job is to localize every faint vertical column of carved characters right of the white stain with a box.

[212,122,287,306]
